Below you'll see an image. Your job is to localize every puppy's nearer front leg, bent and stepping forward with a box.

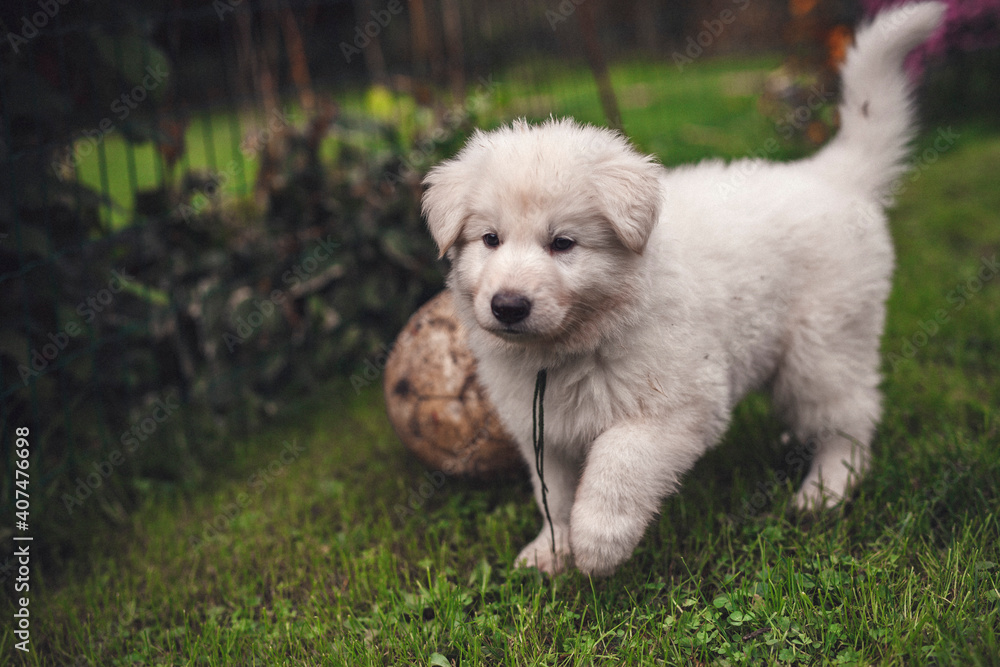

[570,415,704,576]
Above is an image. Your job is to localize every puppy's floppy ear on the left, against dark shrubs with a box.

[421,135,483,257]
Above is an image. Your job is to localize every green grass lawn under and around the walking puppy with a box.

[0,58,1000,667]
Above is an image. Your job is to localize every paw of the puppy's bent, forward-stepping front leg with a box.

[570,504,646,577]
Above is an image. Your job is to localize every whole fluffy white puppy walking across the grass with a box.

[423,2,944,574]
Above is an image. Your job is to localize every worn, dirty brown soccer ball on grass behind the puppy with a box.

[385,290,524,478]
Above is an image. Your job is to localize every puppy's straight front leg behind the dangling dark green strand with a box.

[514,447,580,574]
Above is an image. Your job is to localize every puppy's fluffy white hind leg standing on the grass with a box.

[774,312,882,510]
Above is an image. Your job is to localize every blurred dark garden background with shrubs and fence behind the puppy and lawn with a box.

[0,0,1000,664]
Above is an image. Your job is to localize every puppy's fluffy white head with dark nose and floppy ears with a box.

[423,120,660,349]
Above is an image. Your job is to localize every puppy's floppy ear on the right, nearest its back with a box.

[592,147,662,254]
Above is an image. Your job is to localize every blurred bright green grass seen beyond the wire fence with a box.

[74,57,795,229]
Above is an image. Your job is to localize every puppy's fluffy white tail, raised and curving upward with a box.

[813,2,946,200]
